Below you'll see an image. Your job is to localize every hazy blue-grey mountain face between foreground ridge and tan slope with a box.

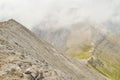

[32,27,70,51]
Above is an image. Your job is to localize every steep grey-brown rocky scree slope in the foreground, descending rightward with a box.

[0,20,106,80]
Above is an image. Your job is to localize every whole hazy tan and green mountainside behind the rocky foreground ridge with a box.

[33,22,120,80]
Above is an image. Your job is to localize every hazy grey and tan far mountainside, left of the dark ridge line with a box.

[32,23,106,58]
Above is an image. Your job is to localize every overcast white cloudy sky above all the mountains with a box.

[0,0,120,28]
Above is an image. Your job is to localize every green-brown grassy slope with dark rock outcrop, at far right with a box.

[88,34,120,80]
